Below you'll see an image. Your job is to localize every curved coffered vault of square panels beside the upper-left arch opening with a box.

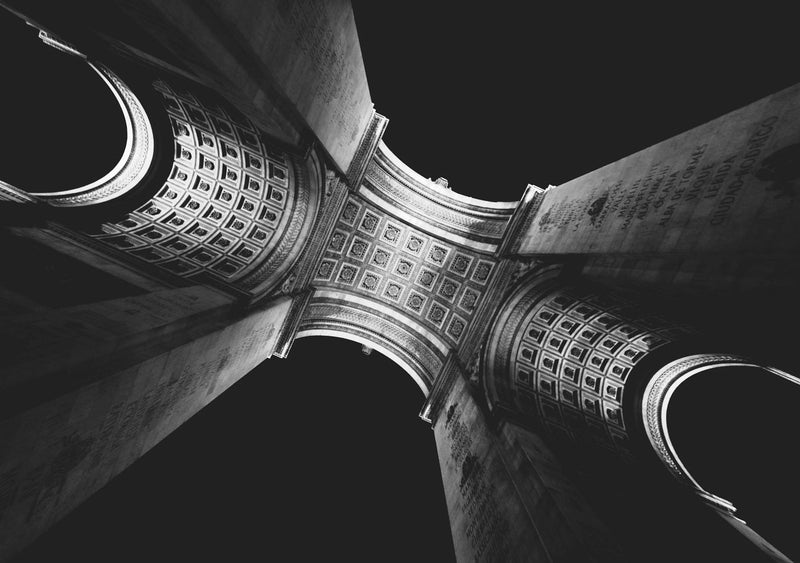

[73,78,325,295]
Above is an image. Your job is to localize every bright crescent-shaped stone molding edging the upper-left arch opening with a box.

[31,63,154,207]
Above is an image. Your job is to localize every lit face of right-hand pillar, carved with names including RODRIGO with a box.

[520,86,800,254]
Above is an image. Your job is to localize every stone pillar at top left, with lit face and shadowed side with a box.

[1,0,374,177]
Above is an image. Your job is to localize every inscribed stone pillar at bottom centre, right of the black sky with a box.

[425,356,625,562]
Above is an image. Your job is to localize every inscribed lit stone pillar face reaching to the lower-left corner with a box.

[0,298,292,560]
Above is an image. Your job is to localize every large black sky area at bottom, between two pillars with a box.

[17,337,455,563]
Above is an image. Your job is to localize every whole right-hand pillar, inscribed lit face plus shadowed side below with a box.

[506,86,800,291]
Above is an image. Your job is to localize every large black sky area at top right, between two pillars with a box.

[353,0,800,201]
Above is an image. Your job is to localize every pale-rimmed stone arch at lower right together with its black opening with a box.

[642,354,800,556]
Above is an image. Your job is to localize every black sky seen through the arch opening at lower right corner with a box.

[667,367,800,561]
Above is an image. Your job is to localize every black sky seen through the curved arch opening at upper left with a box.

[0,8,126,192]
